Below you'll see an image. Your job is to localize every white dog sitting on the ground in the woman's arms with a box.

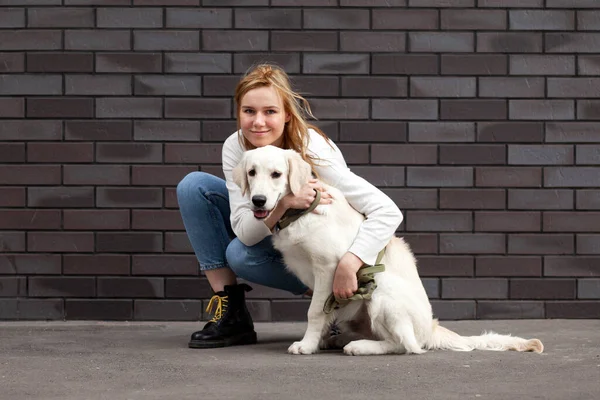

[233,146,543,355]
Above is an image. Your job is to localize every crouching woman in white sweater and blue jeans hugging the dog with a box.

[177,64,402,348]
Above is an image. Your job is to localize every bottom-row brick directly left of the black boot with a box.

[133,299,203,321]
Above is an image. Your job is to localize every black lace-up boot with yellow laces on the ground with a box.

[188,283,256,349]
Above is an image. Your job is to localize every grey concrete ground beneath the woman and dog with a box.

[0,320,600,400]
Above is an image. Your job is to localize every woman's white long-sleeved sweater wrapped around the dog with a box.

[222,129,402,265]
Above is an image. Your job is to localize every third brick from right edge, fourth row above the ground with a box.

[440,233,506,254]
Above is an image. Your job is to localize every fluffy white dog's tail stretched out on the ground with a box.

[425,320,544,353]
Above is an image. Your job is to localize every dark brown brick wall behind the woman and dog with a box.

[0,0,600,321]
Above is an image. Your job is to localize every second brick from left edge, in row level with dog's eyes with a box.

[63,165,130,185]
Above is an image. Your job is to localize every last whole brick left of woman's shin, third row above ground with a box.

[131,255,199,276]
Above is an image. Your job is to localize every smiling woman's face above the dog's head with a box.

[239,86,290,147]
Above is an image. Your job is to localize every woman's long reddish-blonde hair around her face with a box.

[234,64,329,170]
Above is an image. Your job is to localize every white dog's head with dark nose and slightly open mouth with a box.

[233,146,311,219]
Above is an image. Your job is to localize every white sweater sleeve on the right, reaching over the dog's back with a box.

[309,133,403,265]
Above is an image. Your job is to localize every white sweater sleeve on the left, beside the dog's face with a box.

[222,132,271,246]
